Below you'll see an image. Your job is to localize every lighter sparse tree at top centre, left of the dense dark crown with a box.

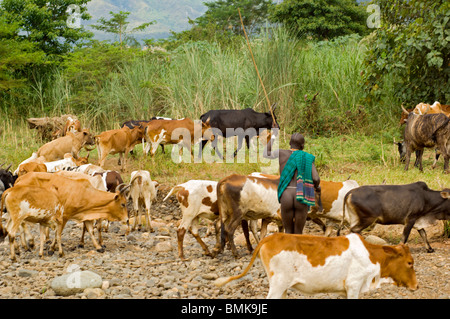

[195,0,272,34]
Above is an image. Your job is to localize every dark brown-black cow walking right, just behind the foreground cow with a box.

[338,182,450,253]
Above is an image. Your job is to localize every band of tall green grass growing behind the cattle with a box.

[3,29,399,135]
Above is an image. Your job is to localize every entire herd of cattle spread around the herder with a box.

[0,102,450,298]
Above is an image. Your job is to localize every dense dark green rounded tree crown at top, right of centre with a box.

[270,0,368,40]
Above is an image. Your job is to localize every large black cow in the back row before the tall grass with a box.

[199,104,279,158]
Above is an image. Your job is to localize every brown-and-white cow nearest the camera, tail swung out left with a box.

[215,233,418,299]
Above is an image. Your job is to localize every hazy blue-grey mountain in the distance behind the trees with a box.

[84,0,208,40]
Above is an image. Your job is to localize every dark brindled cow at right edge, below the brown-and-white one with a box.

[404,112,450,173]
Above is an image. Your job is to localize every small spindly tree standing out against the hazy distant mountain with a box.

[91,11,156,48]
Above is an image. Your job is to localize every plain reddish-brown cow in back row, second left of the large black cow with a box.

[95,126,143,171]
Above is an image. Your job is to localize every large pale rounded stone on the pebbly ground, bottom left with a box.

[50,270,103,296]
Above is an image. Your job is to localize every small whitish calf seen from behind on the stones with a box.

[129,170,158,232]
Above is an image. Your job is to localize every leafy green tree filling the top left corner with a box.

[0,0,92,60]
